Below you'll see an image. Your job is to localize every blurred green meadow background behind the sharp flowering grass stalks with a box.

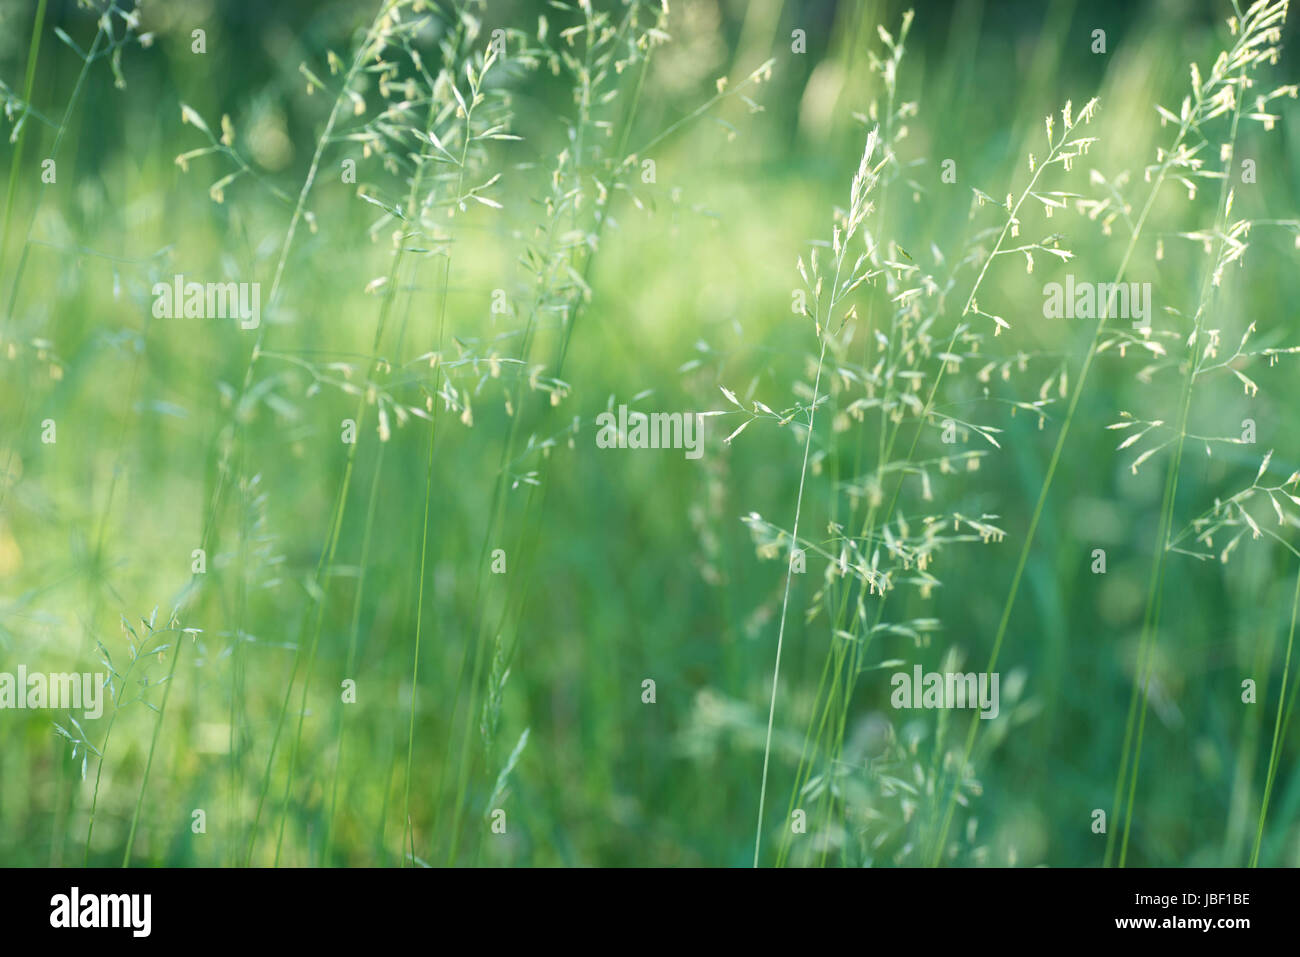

[0,0,1300,866]
